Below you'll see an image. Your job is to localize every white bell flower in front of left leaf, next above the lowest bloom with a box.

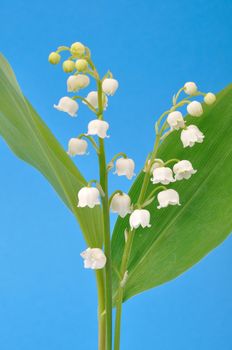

[77,187,100,208]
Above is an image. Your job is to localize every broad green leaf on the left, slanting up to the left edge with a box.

[0,55,102,247]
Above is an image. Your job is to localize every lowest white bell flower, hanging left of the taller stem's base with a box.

[80,248,106,270]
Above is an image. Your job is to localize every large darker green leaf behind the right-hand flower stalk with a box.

[112,85,232,300]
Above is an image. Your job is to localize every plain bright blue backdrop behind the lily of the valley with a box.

[0,0,232,350]
